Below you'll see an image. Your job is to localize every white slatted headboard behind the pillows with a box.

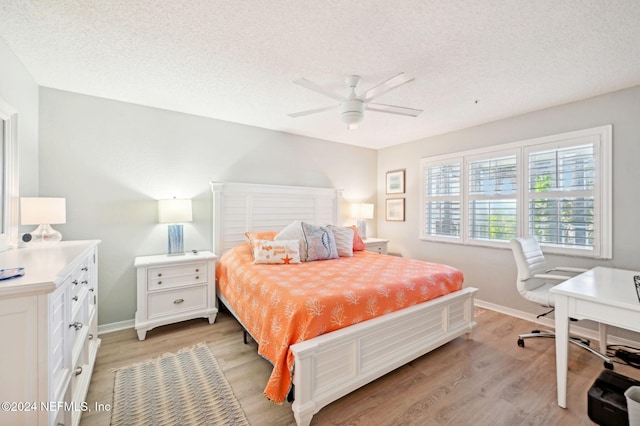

[211,182,342,256]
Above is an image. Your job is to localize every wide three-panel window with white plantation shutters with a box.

[421,126,612,258]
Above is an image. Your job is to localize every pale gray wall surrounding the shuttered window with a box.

[378,86,640,313]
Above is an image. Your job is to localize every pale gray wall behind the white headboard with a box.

[40,88,377,324]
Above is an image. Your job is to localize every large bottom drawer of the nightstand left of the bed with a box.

[148,285,207,318]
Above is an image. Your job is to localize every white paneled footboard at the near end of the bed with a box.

[291,287,477,426]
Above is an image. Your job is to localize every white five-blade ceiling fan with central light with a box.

[289,73,422,130]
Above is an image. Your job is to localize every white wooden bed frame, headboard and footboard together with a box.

[211,182,477,426]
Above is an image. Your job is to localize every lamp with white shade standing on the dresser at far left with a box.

[20,197,67,242]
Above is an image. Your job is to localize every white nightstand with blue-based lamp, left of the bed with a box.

[134,251,218,340]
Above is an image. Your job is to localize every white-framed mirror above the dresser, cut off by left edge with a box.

[0,99,19,251]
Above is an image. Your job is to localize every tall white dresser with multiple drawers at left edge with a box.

[0,240,100,425]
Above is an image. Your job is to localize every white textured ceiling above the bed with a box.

[0,0,640,148]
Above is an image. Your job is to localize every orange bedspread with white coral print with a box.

[217,243,463,403]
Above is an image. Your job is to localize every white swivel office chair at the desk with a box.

[511,237,613,370]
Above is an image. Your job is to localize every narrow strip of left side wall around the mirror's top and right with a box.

[0,38,38,196]
